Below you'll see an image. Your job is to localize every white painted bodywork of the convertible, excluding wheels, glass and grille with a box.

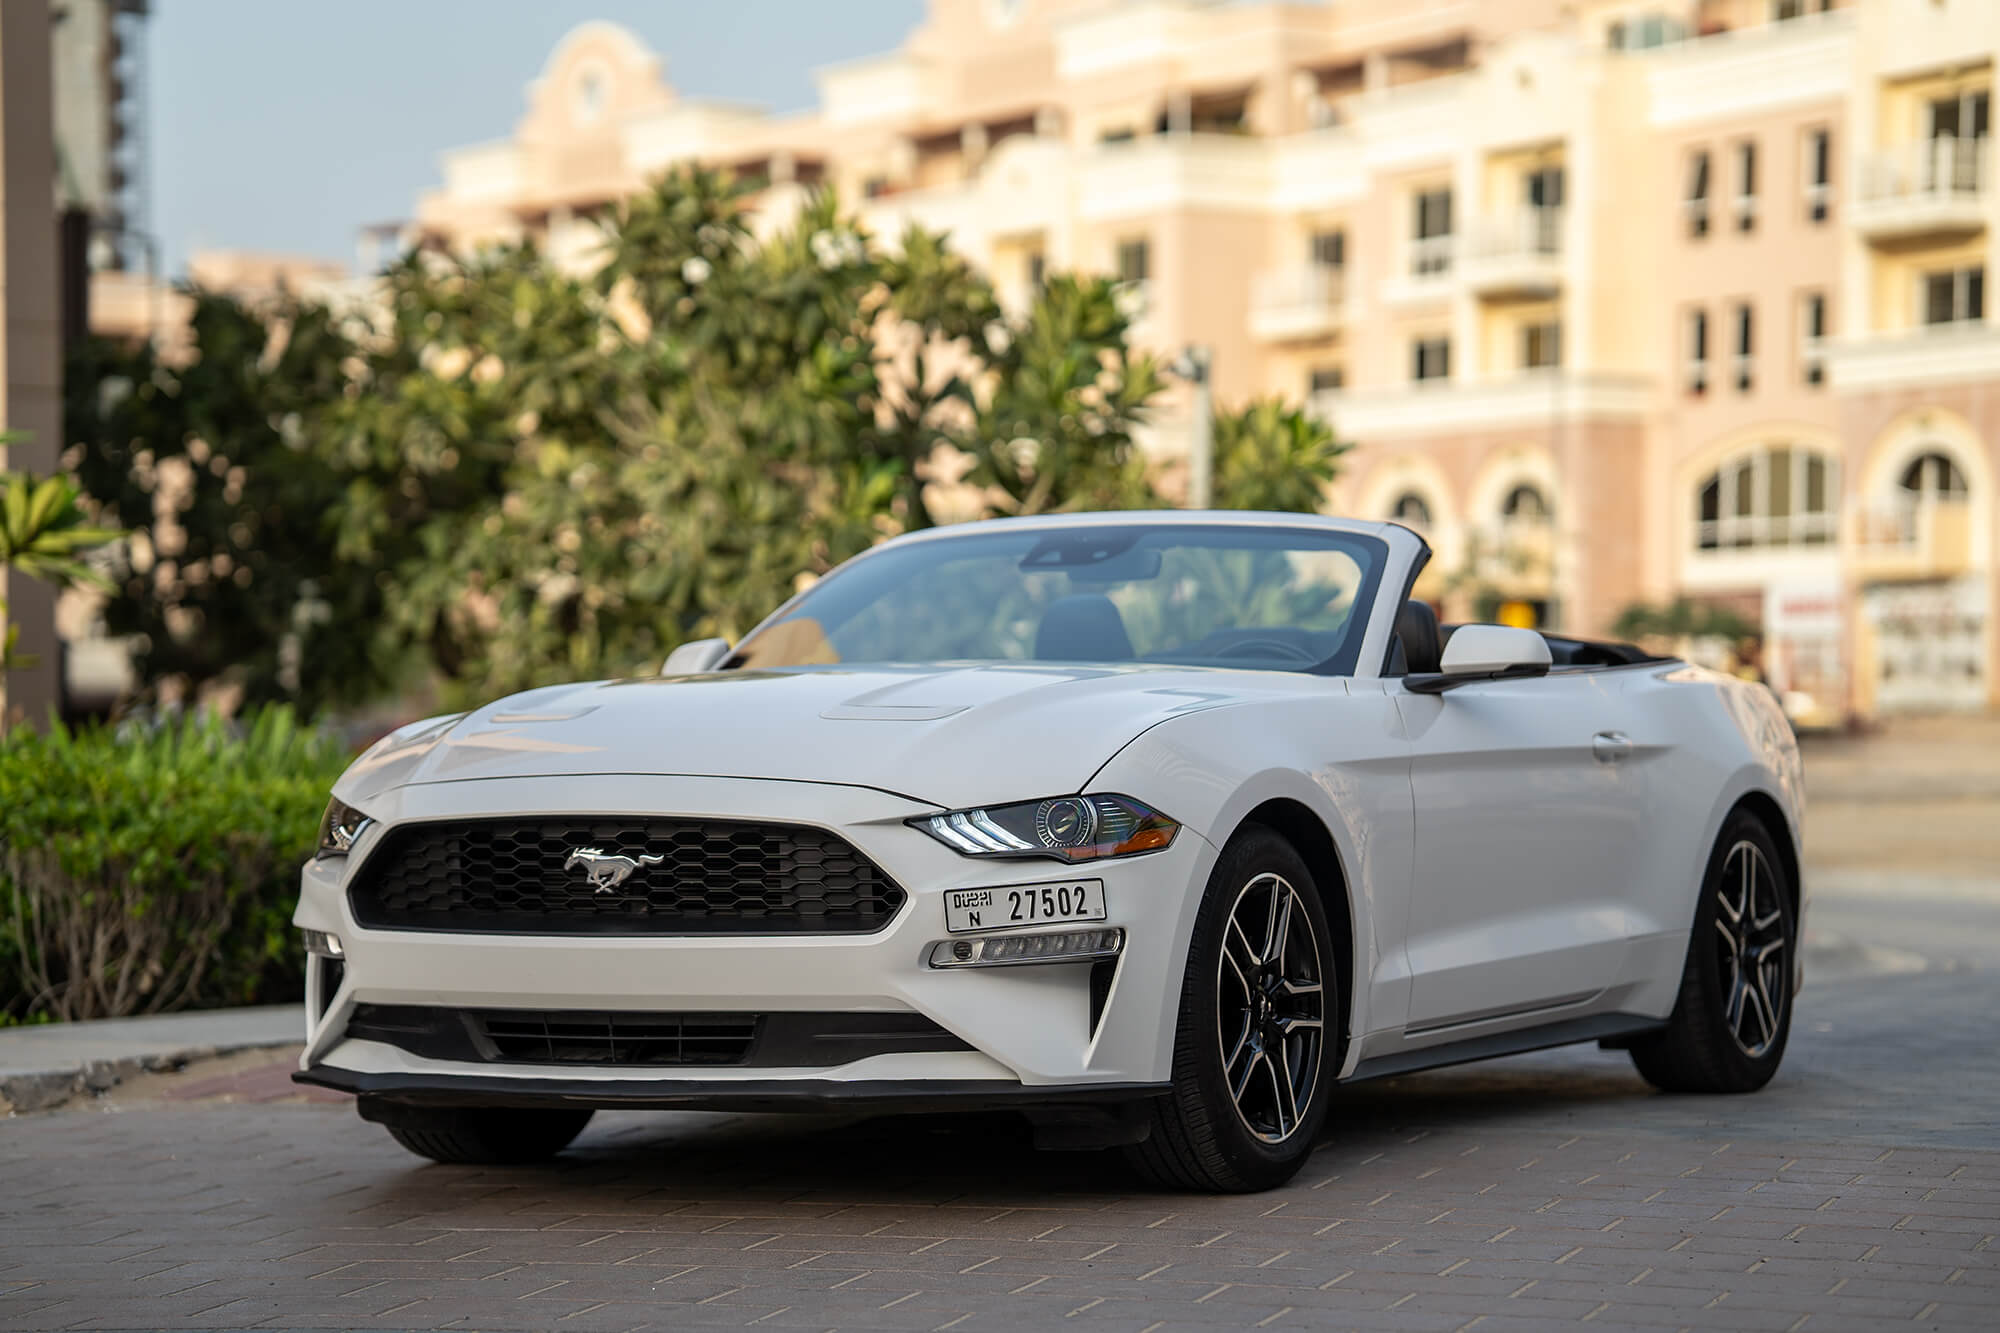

[296,514,1804,1097]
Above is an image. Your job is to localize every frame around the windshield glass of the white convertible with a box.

[716,510,1422,677]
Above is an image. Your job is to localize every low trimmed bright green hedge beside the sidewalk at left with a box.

[0,709,348,1021]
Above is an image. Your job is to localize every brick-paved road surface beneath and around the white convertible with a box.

[0,956,2000,1333]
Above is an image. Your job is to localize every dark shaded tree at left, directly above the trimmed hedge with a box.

[64,294,380,703]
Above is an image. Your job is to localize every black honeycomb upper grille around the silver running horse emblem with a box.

[350,819,904,935]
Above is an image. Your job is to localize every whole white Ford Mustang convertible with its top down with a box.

[296,512,1804,1191]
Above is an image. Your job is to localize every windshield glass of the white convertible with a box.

[730,524,1388,675]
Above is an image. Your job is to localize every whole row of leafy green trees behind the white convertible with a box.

[72,170,1338,709]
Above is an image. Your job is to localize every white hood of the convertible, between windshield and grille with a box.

[336,662,1332,807]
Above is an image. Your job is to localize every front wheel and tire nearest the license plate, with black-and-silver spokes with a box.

[1126,825,1346,1193]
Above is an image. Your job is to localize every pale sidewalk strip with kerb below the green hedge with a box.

[0,1005,306,1113]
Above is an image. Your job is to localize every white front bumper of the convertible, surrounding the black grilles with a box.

[294,775,1216,1109]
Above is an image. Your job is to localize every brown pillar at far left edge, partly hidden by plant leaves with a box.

[0,2,62,725]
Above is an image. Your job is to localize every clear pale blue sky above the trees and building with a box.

[146,0,924,274]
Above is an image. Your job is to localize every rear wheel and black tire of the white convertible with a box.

[1632,811,1798,1093]
